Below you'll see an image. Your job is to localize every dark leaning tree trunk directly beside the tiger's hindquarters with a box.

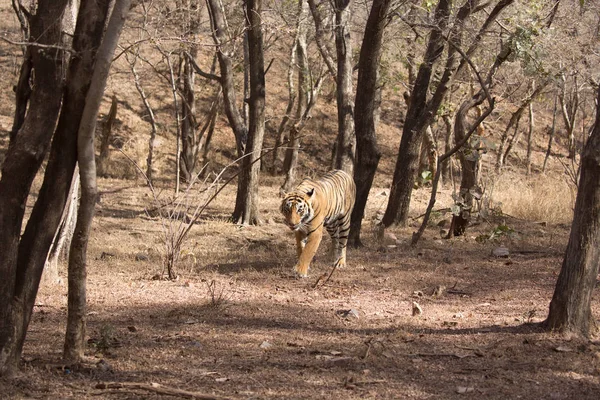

[348,0,391,247]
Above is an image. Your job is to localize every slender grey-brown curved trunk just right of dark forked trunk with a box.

[64,0,131,362]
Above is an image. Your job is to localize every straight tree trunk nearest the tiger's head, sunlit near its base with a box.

[232,0,265,225]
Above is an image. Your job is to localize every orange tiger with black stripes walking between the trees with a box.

[281,170,356,278]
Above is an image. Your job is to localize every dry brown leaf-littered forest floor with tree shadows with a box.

[0,178,600,399]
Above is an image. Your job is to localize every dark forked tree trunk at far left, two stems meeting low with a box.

[0,0,109,375]
